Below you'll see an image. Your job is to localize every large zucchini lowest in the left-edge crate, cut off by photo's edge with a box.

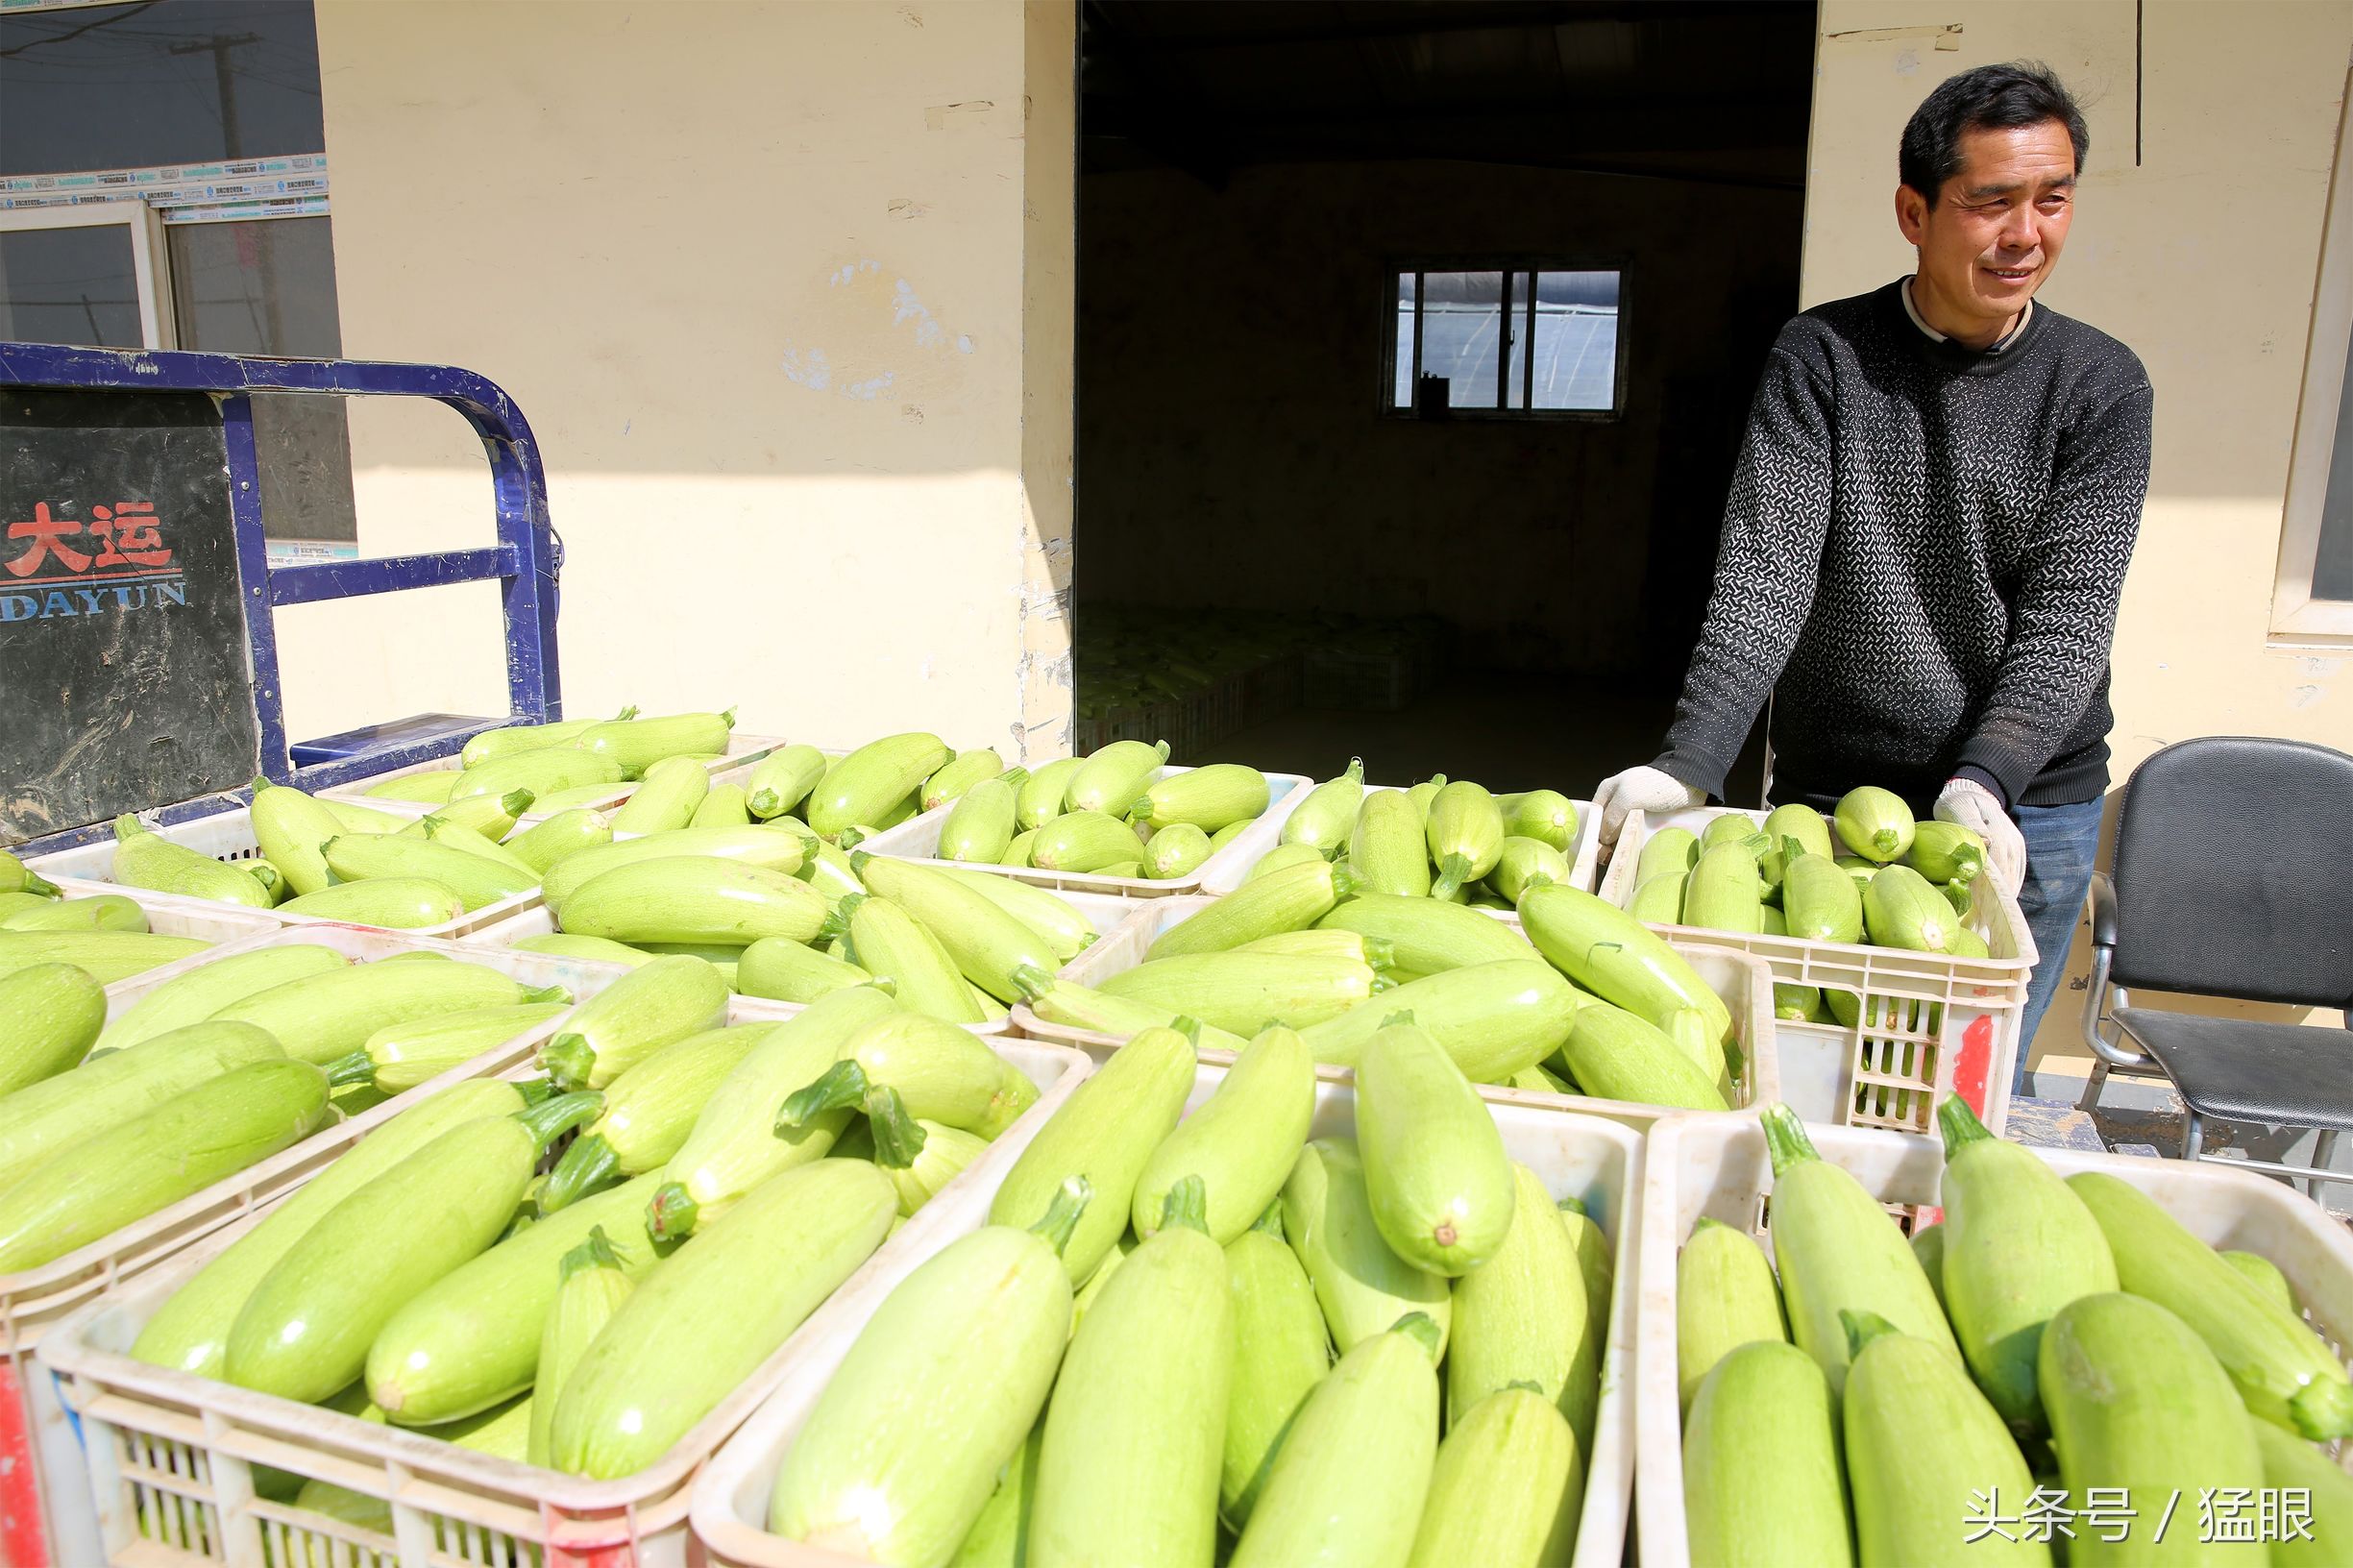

[0,1060,331,1271]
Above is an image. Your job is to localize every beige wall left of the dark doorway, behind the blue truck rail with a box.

[303,0,1075,747]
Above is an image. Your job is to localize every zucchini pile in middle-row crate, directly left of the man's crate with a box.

[1017,866,1739,1112]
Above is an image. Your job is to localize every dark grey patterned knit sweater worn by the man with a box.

[1656,282,2150,808]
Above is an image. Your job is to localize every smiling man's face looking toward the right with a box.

[1897,120,2075,346]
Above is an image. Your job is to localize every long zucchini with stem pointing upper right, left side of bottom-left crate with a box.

[221,1094,596,1403]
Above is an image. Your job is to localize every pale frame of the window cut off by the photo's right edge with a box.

[2270,73,2353,645]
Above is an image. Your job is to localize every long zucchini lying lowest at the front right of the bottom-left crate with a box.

[546,1161,899,1481]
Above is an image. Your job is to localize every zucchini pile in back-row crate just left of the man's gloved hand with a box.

[1249,758,1577,909]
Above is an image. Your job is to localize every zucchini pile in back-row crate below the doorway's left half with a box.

[898,742,1270,883]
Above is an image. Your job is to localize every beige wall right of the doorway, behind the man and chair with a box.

[1802,0,2353,1073]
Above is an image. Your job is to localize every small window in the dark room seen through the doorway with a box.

[1388,266,1624,419]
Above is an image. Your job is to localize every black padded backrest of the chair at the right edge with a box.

[2111,735,2353,1008]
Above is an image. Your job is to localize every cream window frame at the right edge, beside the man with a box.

[2270,78,2353,643]
